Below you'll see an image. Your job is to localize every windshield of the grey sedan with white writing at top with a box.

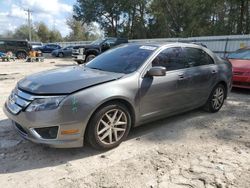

[86,44,157,74]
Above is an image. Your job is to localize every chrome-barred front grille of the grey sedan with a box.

[6,89,34,114]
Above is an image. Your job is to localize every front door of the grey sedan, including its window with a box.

[140,47,189,121]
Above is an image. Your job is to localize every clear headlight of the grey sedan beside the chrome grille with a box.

[26,96,65,112]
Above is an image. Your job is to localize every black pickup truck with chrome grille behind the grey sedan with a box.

[72,37,128,64]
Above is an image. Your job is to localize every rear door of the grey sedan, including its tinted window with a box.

[183,47,218,105]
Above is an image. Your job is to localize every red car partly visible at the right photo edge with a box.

[228,47,250,89]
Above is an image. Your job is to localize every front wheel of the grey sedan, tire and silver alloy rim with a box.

[86,103,131,150]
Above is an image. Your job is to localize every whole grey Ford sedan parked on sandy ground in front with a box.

[4,43,232,149]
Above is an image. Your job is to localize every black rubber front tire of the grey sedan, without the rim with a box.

[86,103,131,150]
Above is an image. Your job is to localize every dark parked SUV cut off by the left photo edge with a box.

[0,39,31,59]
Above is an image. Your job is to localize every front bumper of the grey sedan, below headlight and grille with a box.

[3,89,85,148]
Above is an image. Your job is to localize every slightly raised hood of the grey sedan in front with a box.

[18,66,124,95]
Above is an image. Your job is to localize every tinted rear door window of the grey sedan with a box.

[184,48,214,67]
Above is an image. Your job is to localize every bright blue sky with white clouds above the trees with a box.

[0,0,76,36]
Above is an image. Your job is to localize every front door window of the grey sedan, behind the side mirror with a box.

[152,47,187,71]
